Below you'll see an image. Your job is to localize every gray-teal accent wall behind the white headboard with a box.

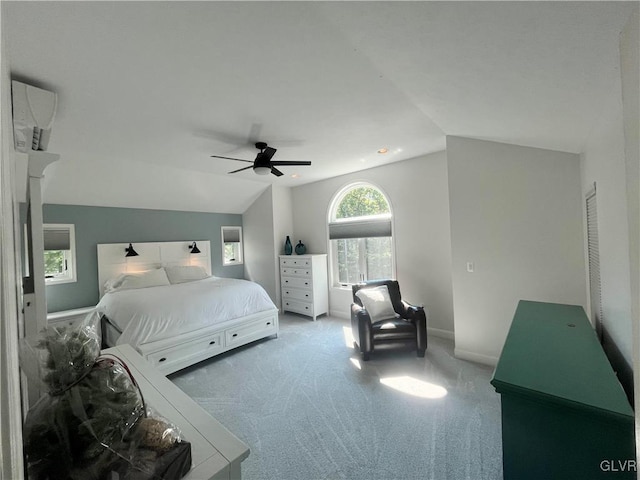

[21,204,244,312]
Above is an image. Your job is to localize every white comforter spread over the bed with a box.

[96,277,276,347]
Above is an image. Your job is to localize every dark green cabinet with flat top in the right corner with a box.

[491,300,636,480]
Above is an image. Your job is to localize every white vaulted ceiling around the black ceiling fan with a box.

[2,1,632,213]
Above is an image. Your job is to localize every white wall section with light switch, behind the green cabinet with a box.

[447,137,586,364]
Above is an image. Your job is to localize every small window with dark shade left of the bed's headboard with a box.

[30,223,76,285]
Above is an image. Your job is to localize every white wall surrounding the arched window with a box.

[293,152,453,337]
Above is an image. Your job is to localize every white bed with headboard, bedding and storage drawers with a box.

[96,241,278,375]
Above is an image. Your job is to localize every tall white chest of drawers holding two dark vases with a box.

[280,253,329,320]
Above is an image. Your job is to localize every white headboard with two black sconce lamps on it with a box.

[98,240,211,298]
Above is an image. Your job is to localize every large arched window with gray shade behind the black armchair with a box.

[329,183,394,285]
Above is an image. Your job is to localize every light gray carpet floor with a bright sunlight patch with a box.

[169,314,502,480]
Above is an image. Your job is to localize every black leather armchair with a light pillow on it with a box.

[351,280,427,361]
